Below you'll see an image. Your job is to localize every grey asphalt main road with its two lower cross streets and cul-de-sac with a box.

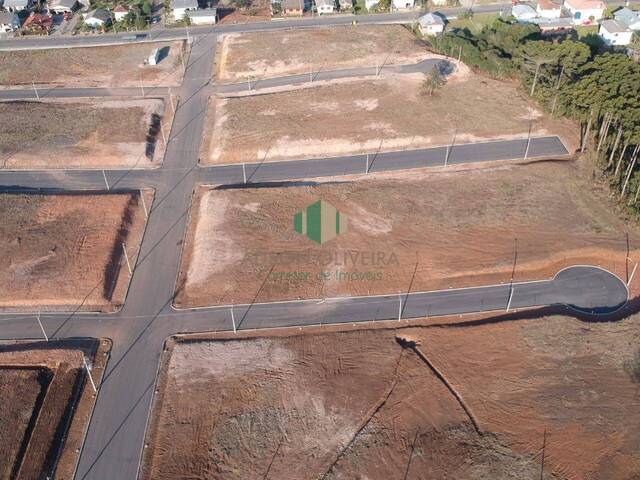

[0,17,627,480]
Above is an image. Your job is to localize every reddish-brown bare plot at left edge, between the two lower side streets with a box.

[0,192,151,311]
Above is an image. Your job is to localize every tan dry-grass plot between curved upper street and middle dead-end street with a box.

[202,71,575,164]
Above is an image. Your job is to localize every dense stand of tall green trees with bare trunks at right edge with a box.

[431,19,640,213]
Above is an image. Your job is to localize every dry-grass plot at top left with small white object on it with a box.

[0,41,188,88]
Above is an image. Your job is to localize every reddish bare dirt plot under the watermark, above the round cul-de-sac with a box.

[176,160,640,307]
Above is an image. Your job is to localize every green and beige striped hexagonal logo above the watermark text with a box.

[293,200,347,244]
